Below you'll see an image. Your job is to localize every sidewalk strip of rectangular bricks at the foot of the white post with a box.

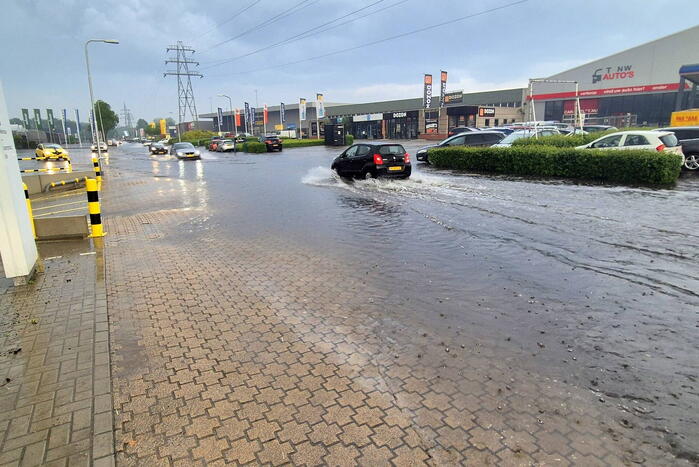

[0,241,114,466]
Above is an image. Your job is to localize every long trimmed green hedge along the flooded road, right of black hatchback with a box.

[428,145,682,185]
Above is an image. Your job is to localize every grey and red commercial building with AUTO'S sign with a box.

[526,26,699,126]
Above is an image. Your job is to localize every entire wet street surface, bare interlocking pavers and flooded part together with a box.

[97,142,699,465]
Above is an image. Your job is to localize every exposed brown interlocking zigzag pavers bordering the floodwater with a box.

[102,166,675,466]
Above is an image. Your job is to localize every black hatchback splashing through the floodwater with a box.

[330,143,412,178]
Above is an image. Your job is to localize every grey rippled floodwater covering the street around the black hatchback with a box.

[100,142,699,461]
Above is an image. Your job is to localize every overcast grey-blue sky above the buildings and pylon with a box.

[0,0,699,120]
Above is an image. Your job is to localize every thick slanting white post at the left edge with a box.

[0,83,39,285]
